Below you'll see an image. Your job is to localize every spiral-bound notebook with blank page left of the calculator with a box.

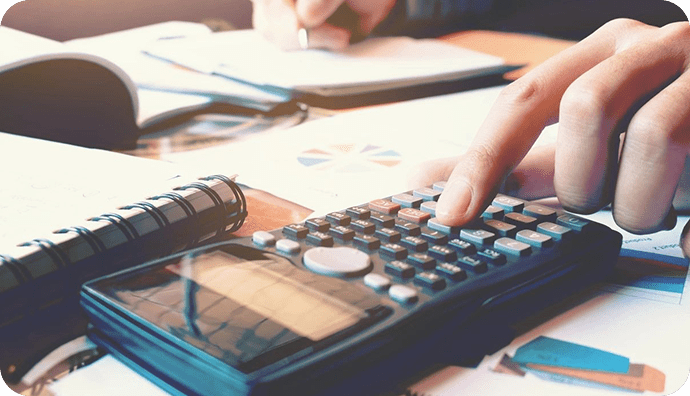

[0,133,247,382]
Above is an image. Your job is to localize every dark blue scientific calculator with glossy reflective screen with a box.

[81,183,621,396]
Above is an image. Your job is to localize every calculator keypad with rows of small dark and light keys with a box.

[254,188,589,305]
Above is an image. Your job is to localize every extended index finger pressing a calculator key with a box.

[436,20,647,225]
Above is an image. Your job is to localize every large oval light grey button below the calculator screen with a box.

[303,246,372,276]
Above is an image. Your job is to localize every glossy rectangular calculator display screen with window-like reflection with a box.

[92,245,387,373]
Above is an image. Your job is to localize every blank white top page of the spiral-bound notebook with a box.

[0,133,179,251]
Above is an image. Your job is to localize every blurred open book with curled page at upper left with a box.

[0,22,289,149]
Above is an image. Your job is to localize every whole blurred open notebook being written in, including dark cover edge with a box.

[145,30,516,107]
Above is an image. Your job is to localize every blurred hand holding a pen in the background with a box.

[252,0,396,50]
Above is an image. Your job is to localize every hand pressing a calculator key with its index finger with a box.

[408,19,690,233]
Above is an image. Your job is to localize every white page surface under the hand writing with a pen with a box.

[146,30,504,89]
